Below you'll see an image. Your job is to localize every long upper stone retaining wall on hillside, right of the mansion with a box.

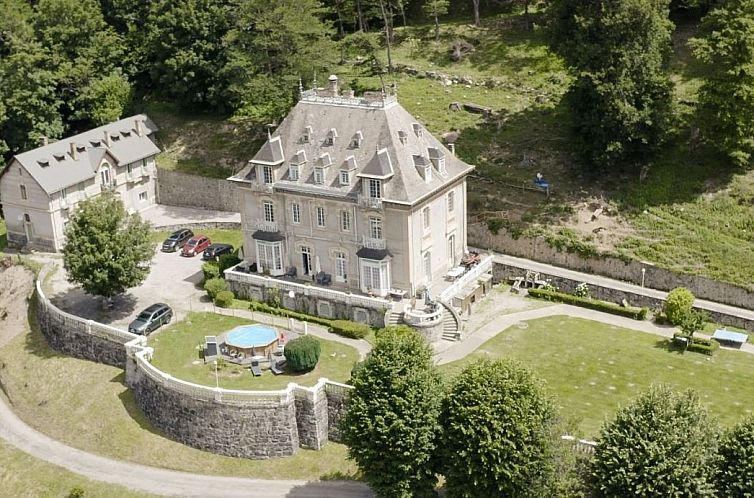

[468,223,754,312]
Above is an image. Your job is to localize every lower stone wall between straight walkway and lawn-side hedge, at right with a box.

[492,262,754,331]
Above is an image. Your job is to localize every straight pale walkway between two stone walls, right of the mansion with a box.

[490,253,754,320]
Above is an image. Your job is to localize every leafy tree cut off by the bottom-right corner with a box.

[715,415,754,498]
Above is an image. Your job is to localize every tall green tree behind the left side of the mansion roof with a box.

[223,0,338,120]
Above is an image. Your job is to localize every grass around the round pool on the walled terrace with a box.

[149,313,358,390]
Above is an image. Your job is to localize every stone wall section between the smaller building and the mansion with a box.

[157,169,239,213]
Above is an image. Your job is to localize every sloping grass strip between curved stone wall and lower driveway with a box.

[0,308,356,478]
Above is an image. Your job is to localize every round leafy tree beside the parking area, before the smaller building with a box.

[63,194,155,298]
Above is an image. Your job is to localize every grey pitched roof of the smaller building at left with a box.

[13,114,160,194]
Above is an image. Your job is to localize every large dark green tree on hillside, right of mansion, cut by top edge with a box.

[549,0,673,168]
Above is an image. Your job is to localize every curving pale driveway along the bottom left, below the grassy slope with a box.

[0,395,373,498]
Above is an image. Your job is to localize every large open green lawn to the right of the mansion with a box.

[440,316,754,437]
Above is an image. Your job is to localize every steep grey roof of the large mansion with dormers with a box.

[232,96,474,204]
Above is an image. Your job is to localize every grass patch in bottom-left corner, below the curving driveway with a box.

[0,441,157,498]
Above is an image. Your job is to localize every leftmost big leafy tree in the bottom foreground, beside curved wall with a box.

[341,332,441,498]
